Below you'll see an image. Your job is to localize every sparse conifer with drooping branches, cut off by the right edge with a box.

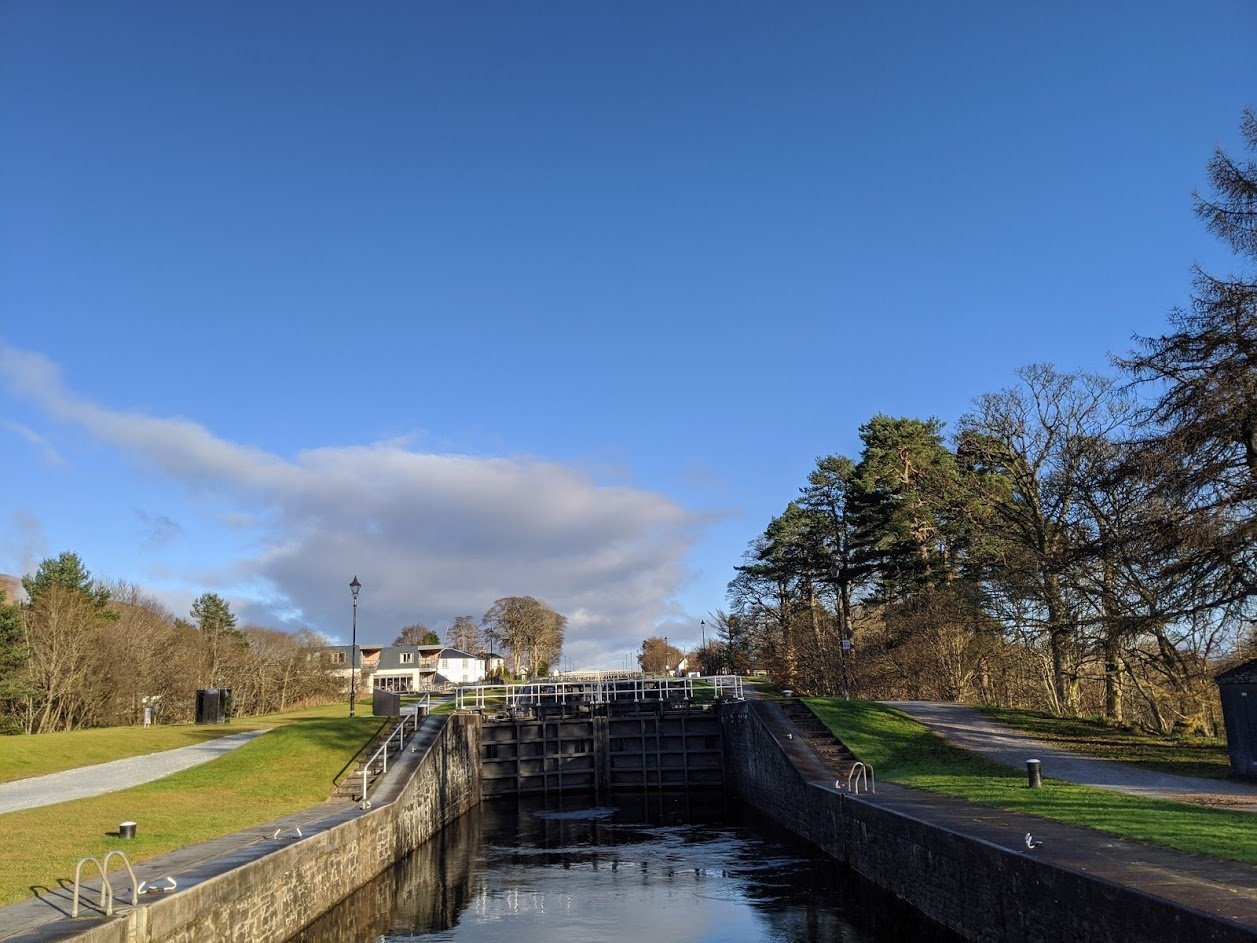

[1119,111,1257,605]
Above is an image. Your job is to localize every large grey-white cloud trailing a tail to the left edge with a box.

[0,343,701,665]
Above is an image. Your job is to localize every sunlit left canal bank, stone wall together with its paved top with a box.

[0,717,480,943]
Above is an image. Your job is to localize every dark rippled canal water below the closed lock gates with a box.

[292,795,958,943]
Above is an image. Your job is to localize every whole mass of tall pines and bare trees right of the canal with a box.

[725,112,1257,733]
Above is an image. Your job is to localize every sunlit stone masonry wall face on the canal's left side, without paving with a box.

[84,717,480,943]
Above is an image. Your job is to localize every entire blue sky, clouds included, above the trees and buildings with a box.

[0,0,1257,664]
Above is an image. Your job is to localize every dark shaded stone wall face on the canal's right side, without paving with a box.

[725,705,1254,943]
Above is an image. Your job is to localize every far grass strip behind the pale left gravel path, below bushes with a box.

[0,702,371,782]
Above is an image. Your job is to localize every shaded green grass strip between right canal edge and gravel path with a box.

[807,698,1257,864]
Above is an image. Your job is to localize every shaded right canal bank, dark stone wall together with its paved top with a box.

[724,702,1257,943]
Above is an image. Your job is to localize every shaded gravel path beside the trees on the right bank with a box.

[887,700,1257,812]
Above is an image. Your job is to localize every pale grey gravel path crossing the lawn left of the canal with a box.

[0,731,265,813]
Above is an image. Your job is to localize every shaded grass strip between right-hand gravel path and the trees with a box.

[978,707,1231,780]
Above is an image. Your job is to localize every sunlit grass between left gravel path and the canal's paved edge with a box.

[0,704,381,904]
